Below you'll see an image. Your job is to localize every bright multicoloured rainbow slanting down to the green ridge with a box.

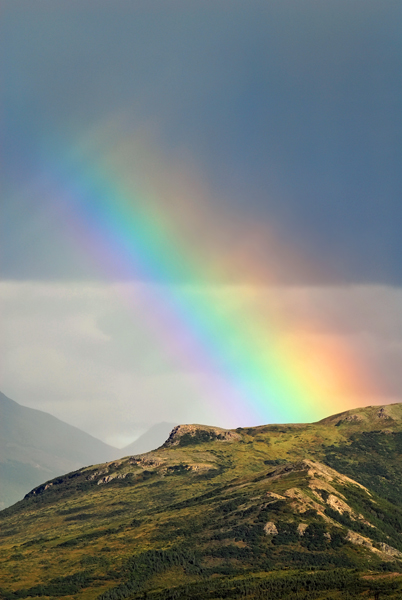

[38,129,380,426]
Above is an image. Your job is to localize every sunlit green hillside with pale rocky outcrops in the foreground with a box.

[0,404,402,600]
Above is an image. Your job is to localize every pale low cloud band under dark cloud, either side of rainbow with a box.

[0,282,402,446]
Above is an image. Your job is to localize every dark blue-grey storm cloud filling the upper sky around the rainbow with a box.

[0,0,402,284]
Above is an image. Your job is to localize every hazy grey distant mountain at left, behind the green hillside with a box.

[0,393,119,508]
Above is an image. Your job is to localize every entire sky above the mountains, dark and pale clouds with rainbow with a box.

[0,0,402,447]
